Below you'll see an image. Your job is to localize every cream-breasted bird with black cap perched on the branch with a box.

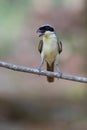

[36,24,62,83]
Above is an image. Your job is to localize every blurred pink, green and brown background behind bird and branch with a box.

[0,0,87,130]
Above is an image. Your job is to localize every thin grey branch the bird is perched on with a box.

[0,61,87,83]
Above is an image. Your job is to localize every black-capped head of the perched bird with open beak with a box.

[36,24,55,37]
